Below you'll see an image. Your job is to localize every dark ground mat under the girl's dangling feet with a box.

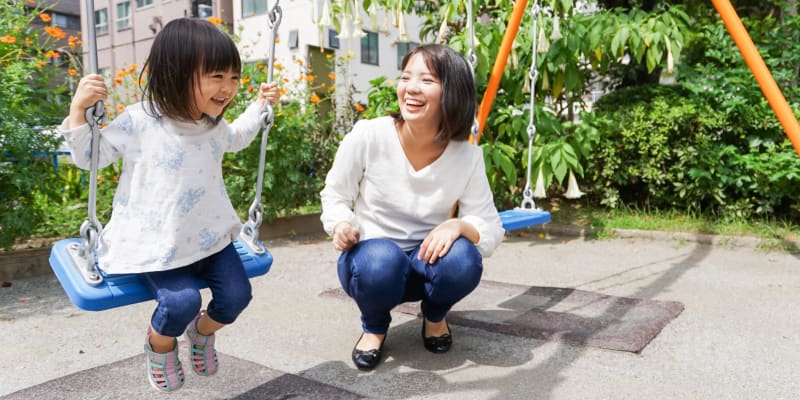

[0,345,363,400]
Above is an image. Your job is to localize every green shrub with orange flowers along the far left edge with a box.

[0,1,80,248]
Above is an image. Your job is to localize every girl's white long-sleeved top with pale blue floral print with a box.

[59,103,261,274]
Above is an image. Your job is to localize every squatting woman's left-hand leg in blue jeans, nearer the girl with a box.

[338,239,409,335]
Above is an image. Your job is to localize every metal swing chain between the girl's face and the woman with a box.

[240,0,283,253]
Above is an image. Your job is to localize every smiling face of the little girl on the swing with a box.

[192,71,239,120]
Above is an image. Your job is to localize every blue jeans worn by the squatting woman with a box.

[338,237,483,334]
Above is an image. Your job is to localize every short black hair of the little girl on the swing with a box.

[139,18,242,124]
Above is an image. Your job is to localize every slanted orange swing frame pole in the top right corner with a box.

[711,0,800,155]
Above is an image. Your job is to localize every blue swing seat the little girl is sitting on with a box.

[50,234,272,311]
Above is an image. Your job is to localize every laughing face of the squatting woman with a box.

[397,54,442,126]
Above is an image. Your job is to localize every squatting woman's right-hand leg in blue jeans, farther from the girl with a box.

[409,237,483,324]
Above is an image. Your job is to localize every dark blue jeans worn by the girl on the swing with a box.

[142,243,253,337]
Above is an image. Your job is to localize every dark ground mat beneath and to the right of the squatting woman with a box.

[321,280,683,353]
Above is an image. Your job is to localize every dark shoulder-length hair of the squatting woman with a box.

[390,44,476,140]
